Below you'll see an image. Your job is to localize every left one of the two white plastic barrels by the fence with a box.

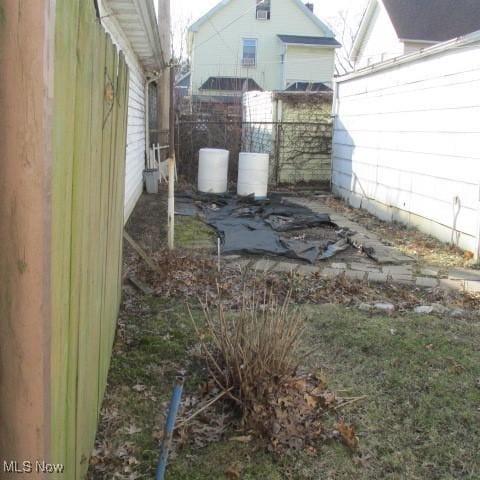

[198,148,229,193]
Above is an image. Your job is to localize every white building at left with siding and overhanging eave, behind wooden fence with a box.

[98,0,164,222]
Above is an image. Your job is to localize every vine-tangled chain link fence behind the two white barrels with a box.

[175,94,332,188]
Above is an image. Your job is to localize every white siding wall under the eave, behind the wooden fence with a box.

[99,12,146,222]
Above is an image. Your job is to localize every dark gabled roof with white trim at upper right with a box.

[351,0,480,57]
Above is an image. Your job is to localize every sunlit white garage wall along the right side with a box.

[332,34,480,253]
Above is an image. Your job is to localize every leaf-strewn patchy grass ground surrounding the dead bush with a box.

[88,192,480,480]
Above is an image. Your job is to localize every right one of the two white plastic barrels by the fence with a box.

[237,152,269,198]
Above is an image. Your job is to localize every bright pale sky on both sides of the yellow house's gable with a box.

[158,0,367,58]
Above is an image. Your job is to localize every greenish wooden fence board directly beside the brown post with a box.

[50,0,80,472]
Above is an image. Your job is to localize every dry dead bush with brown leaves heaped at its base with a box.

[192,289,356,455]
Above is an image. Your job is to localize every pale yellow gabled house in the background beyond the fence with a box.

[189,0,340,95]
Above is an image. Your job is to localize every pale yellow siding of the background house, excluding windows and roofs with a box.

[191,0,333,94]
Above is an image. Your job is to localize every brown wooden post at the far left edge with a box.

[0,0,54,472]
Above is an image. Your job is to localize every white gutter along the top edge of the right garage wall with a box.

[336,30,480,83]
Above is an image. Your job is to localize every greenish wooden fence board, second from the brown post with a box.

[71,2,96,472]
